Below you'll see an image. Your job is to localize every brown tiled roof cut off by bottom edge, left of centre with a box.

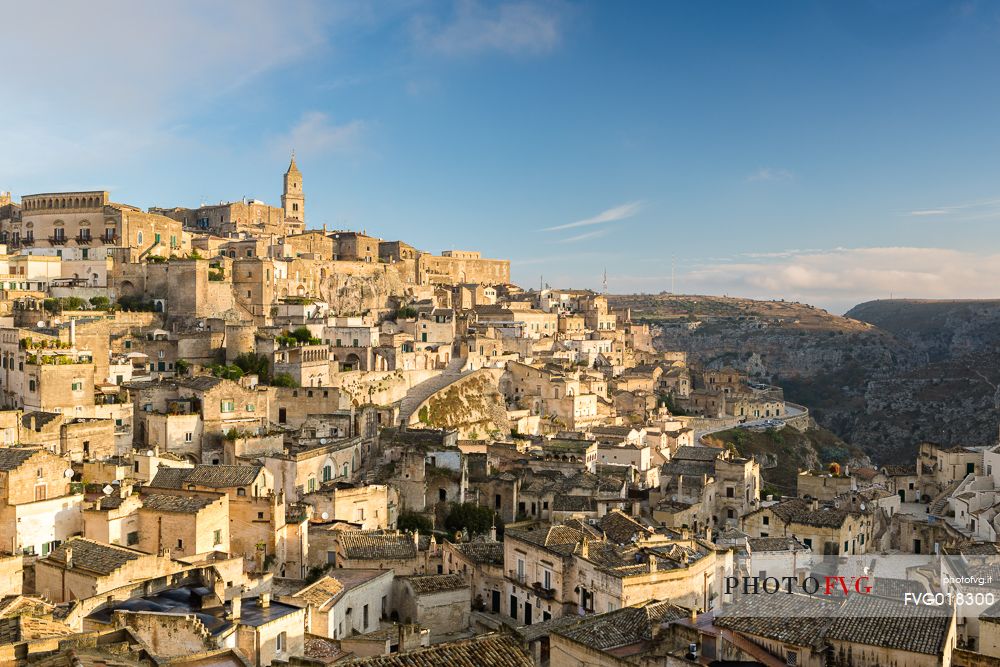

[341,634,534,667]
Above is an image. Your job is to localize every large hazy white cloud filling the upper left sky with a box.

[0,0,348,182]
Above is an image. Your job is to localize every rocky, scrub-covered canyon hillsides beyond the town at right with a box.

[611,295,1000,463]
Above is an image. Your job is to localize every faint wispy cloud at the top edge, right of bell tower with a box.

[412,0,563,56]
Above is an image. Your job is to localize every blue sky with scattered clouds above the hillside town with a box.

[0,0,1000,311]
